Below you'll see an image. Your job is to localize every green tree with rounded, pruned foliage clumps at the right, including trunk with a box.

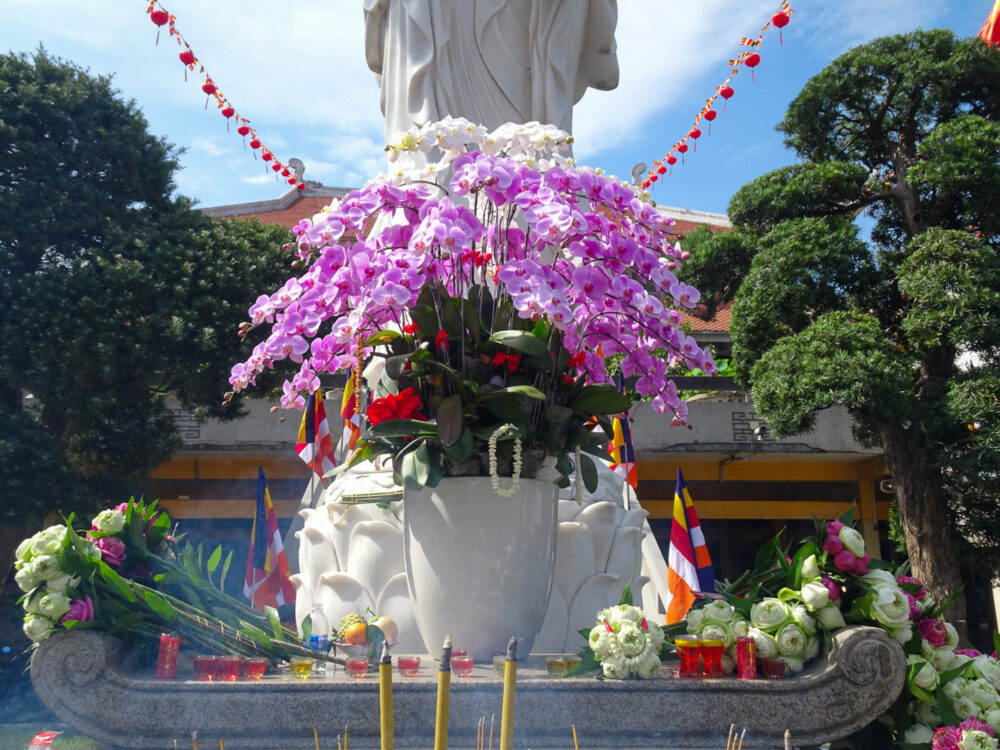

[686,31,1000,621]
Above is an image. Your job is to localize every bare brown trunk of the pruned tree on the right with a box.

[880,425,968,641]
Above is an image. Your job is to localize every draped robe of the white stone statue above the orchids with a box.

[364,0,618,143]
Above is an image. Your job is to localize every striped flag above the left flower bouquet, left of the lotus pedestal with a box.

[243,466,295,610]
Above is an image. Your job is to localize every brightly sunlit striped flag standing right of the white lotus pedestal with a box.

[665,469,715,625]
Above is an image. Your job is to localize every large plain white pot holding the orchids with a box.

[403,477,557,663]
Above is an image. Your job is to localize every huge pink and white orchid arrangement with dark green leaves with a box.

[230,120,715,486]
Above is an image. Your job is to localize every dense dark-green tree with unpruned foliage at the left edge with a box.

[0,51,291,577]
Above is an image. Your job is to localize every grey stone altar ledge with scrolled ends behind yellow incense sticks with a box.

[31,627,906,750]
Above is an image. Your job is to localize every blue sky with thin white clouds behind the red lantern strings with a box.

[0,0,992,212]
